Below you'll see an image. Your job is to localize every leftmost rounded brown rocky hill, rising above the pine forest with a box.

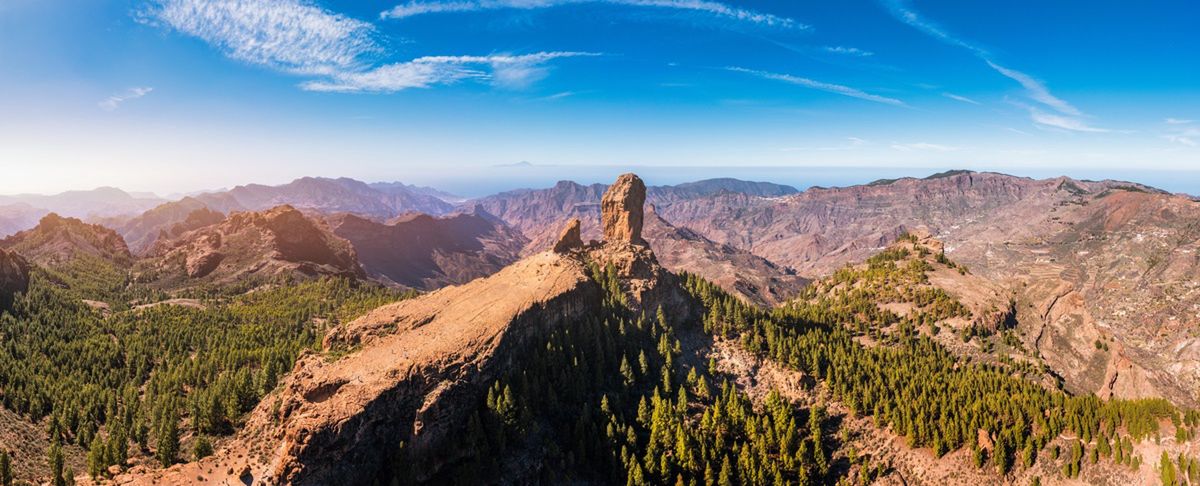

[0,212,133,266]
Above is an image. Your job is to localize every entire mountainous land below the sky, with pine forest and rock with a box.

[0,172,1200,485]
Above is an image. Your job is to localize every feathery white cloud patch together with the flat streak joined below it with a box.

[140,0,596,93]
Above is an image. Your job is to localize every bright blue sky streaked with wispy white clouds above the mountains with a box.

[0,0,1200,194]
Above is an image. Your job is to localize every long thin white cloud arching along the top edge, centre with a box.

[379,0,809,30]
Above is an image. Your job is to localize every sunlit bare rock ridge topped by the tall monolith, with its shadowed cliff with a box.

[118,172,689,485]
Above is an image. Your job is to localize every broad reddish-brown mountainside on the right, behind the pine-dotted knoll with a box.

[643,172,1200,406]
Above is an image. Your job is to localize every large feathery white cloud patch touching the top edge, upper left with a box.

[142,0,382,76]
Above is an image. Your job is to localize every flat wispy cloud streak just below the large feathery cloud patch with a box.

[300,52,600,92]
